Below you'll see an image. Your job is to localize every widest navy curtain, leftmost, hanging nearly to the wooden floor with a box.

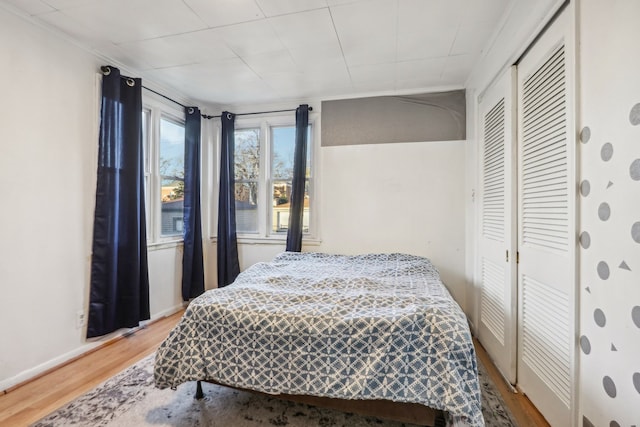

[87,67,150,338]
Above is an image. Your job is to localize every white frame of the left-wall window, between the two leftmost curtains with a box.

[142,94,186,247]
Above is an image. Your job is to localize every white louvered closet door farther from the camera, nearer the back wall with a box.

[477,67,517,384]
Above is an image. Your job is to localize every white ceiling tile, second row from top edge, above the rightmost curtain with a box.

[269,8,338,50]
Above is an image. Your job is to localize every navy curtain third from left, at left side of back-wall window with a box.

[218,111,240,288]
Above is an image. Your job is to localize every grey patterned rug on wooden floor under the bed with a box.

[33,355,516,427]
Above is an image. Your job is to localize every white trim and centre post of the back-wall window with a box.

[210,113,320,246]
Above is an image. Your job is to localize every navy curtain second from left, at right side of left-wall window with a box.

[182,107,204,301]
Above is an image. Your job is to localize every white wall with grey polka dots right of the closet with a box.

[578,0,640,427]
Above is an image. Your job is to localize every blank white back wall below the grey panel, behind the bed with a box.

[319,141,466,308]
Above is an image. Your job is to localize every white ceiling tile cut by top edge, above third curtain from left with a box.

[184,0,264,28]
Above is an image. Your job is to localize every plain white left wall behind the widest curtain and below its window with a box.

[0,8,185,390]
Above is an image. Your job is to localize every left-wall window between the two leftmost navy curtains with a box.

[142,99,184,243]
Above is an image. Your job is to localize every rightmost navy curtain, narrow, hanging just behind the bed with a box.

[286,104,309,252]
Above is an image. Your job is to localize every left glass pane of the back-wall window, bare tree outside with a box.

[234,129,260,233]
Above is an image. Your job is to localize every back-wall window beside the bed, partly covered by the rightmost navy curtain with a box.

[229,117,314,239]
